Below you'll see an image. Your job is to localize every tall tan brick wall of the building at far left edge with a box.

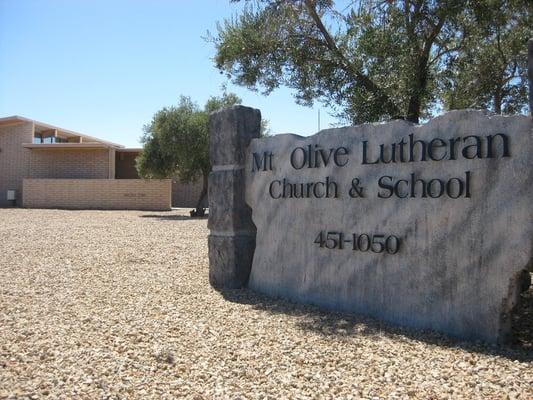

[0,122,33,207]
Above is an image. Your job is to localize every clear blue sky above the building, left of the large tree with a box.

[0,0,335,147]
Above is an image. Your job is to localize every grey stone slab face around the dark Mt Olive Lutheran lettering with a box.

[245,110,533,342]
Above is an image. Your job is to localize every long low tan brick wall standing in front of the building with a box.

[24,179,171,210]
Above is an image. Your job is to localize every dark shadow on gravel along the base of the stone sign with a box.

[220,287,533,362]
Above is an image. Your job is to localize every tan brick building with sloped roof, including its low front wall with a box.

[0,116,201,210]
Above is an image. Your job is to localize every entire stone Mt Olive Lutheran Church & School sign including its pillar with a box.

[209,40,533,342]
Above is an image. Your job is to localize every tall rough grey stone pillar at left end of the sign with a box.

[207,106,261,289]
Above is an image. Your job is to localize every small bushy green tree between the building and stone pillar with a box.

[137,93,241,216]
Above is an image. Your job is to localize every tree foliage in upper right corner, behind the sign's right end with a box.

[443,0,533,114]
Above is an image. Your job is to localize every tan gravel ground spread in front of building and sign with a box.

[0,209,533,399]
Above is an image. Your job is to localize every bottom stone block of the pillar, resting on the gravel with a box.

[208,234,255,289]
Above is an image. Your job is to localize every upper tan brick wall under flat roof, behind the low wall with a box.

[29,149,109,179]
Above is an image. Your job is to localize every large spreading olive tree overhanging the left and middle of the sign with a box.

[211,0,529,124]
